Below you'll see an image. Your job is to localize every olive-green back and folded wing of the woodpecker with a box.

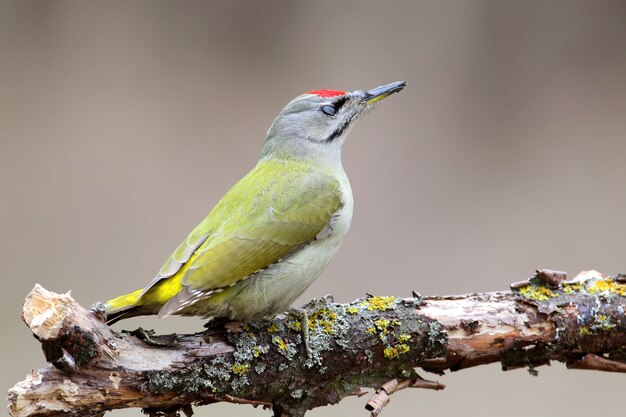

[154,160,342,316]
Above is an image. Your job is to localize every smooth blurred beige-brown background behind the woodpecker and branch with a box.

[0,0,626,417]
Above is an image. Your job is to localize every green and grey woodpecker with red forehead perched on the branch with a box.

[105,81,406,324]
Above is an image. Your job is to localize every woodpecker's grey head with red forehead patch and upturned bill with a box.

[262,81,406,161]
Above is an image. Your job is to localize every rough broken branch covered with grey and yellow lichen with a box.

[8,270,626,417]
